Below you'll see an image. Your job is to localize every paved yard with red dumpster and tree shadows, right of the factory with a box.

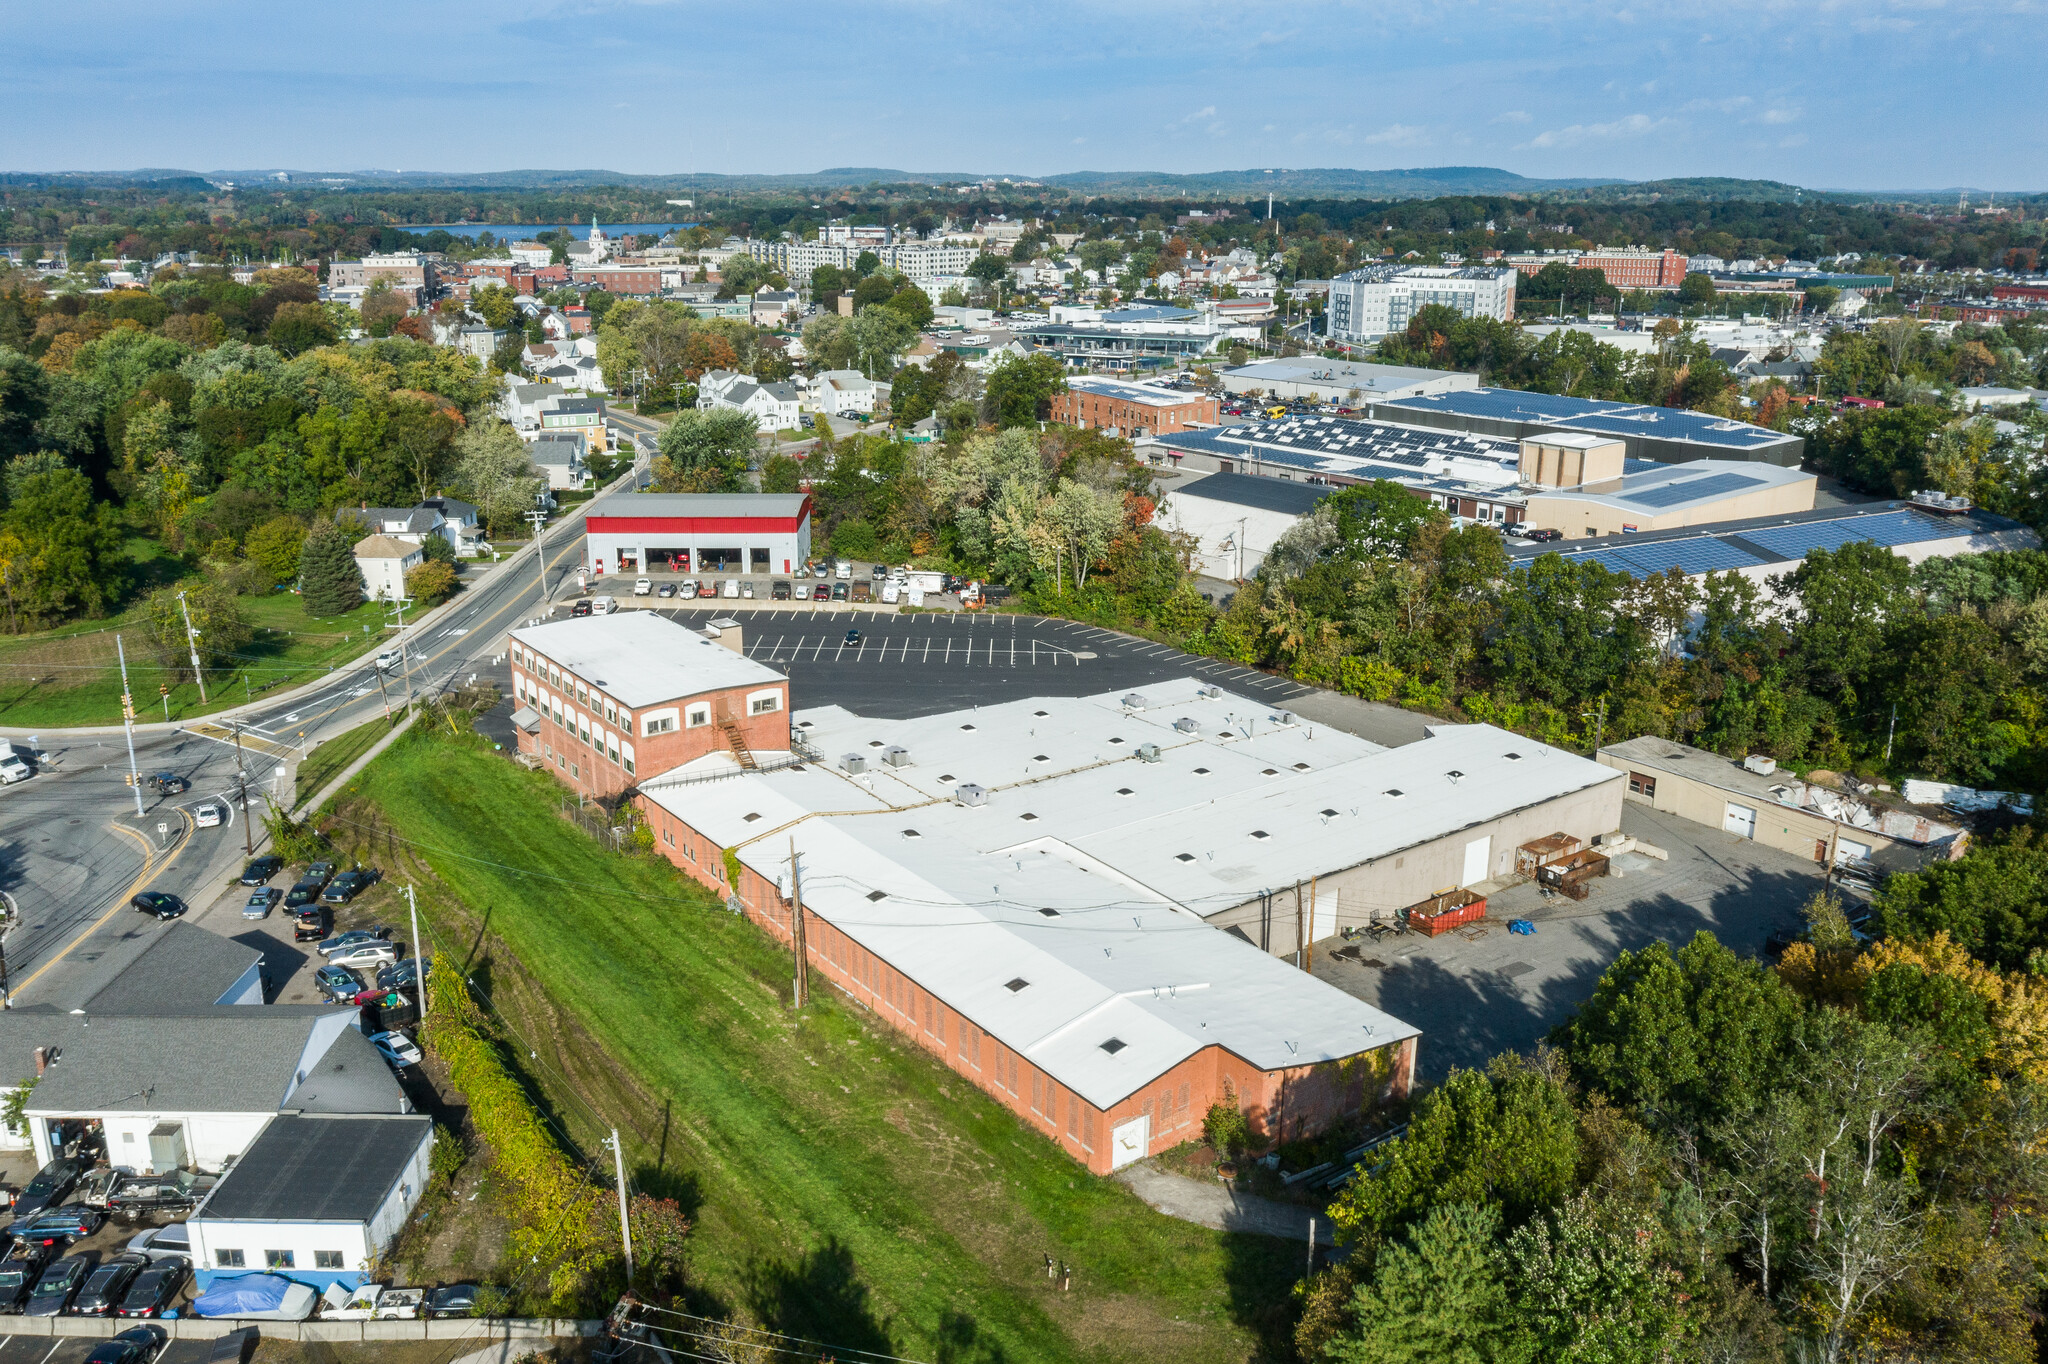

[1315,803,1821,1081]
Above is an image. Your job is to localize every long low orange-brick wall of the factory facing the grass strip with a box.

[639,797,1415,1174]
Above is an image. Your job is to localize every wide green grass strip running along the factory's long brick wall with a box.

[328,721,1298,1364]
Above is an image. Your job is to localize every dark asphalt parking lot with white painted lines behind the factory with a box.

[662,606,1311,719]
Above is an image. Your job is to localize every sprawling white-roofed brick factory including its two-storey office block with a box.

[514,612,1624,1171]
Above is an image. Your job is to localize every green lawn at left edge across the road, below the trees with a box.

[0,592,415,727]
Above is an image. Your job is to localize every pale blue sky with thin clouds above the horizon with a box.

[0,0,2048,190]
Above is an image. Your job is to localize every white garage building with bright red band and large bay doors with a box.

[584,494,811,573]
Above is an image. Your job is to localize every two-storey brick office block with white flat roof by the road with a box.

[512,610,788,799]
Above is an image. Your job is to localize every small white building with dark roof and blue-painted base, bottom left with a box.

[188,1112,434,1288]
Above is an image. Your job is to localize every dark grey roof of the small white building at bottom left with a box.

[193,1114,434,1223]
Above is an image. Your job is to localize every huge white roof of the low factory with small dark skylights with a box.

[641,678,1622,1108]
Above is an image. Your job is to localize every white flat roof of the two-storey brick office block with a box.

[512,610,788,711]
